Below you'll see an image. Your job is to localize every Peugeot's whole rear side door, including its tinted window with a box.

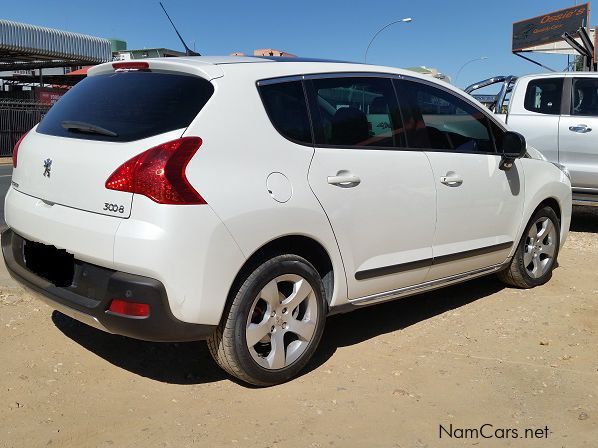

[306,74,436,299]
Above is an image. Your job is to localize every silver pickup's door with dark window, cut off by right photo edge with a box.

[559,77,598,194]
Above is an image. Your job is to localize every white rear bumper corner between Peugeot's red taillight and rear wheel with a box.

[114,195,246,325]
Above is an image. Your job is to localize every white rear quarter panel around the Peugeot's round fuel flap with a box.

[186,70,347,310]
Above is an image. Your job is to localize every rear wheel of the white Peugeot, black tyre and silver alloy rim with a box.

[207,255,327,386]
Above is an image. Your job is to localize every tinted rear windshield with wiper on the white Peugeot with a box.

[37,72,214,142]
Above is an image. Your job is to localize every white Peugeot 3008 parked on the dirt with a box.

[2,57,571,386]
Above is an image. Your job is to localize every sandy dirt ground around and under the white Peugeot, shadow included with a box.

[0,210,598,448]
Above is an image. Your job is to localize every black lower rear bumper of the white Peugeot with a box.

[2,229,216,342]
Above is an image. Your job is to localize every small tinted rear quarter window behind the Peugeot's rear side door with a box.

[259,81,312,145]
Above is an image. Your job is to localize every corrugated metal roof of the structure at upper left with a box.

[0,19,112,70]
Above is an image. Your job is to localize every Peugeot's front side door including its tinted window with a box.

[396,80,524,280]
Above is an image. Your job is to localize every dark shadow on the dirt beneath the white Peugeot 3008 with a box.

[52,276,504,386]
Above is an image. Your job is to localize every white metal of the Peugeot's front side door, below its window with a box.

[426,152,524,280]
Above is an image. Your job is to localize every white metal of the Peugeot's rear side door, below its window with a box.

[309,148,436,299]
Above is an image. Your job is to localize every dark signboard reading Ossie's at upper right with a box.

[513,3,590,52]
